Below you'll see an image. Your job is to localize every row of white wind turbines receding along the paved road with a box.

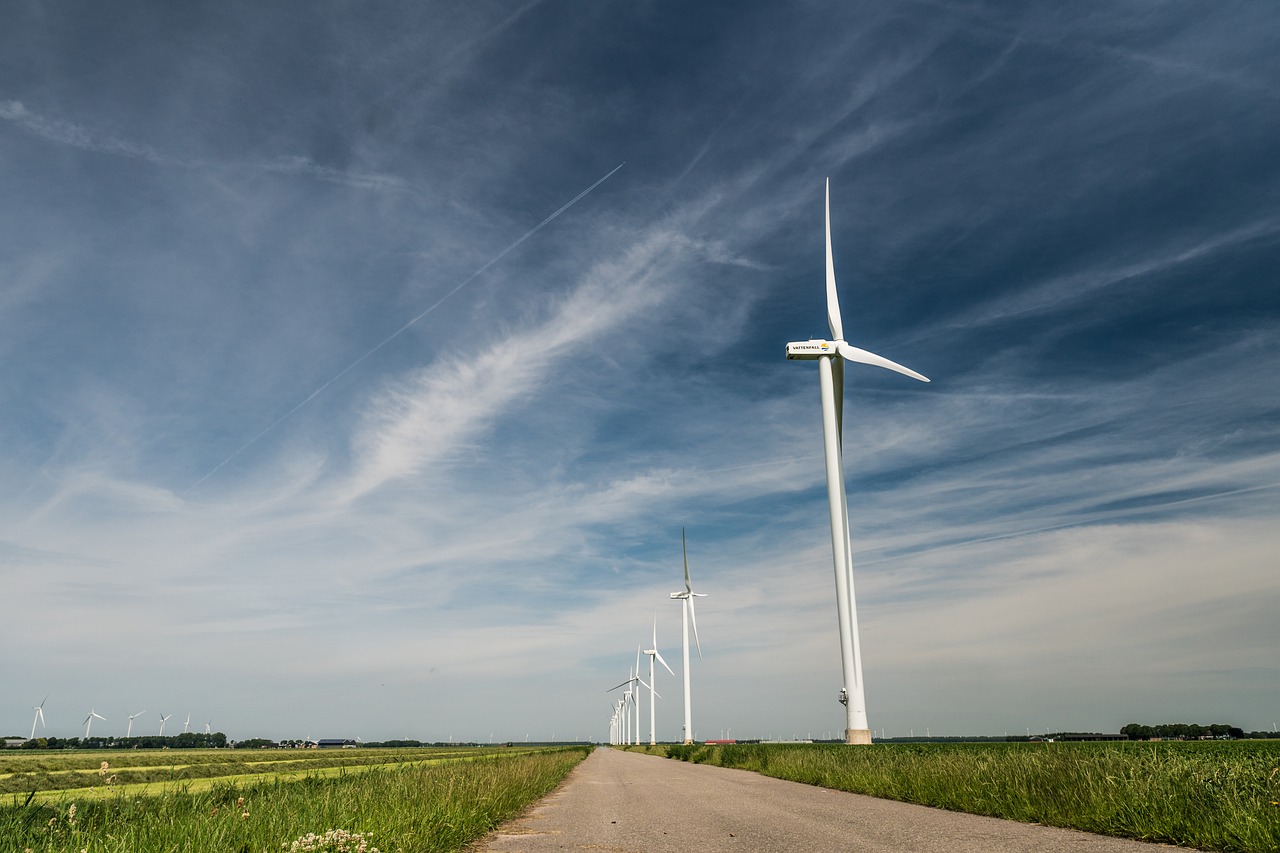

[609,179,929,744]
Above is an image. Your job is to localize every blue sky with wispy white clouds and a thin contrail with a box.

[0,0,1280,740]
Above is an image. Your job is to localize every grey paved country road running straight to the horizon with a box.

[475,749,1170,853]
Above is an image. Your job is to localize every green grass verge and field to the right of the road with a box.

[650,740,1280,853]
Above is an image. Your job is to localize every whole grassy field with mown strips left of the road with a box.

[0,747,588,853]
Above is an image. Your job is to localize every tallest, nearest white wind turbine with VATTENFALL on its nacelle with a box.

[787,179,928,743]
